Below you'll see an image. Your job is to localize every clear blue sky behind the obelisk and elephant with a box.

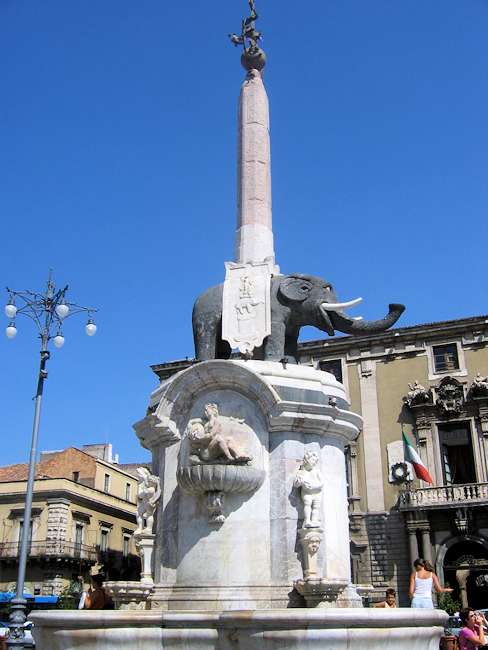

[0,0,488,464]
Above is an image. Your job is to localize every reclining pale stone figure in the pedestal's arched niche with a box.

[187,404,252,463]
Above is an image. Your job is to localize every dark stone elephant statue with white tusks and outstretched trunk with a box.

[192,273,405,362]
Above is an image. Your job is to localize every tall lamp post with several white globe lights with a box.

[5,273,97,648]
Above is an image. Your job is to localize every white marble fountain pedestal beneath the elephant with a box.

[135,360,361,610]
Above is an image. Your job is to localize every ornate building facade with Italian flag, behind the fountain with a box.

[153,316,488,607]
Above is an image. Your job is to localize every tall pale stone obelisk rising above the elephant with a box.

[235,70,274,263]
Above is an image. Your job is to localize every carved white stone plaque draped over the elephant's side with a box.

[222,261,271,354]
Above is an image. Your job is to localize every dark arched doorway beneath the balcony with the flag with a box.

[442,538,488,609]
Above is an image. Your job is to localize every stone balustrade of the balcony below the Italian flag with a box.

[400,483,488,510]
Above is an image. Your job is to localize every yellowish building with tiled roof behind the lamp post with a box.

[0,445,140,595]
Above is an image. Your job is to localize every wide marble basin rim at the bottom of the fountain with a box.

[31,608,447,650]
